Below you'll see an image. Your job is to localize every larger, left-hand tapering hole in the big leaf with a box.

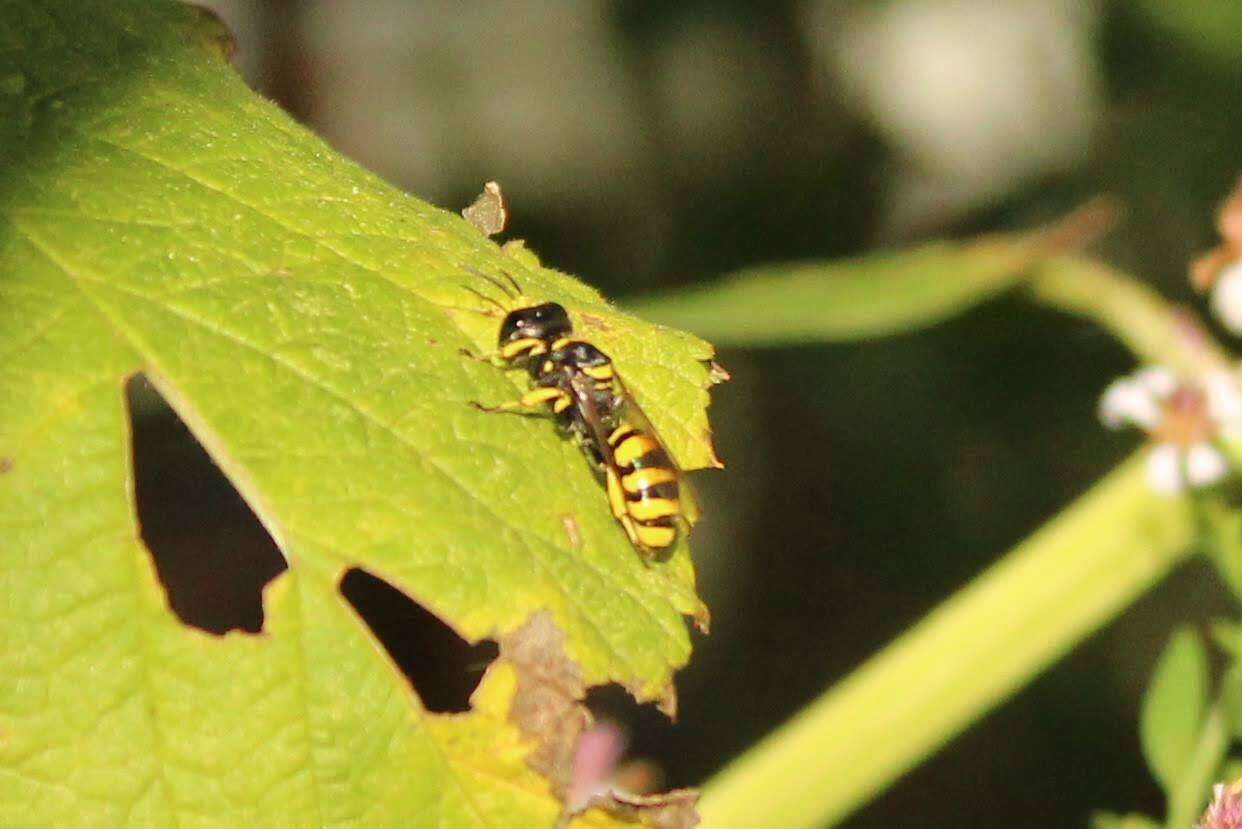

[125,374,284,634]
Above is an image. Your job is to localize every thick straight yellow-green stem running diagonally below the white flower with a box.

[700,456,1194,829]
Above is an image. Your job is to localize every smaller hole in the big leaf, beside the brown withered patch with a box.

[340,568,497,713]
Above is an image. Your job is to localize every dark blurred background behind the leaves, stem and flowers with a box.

[134,0,1242,829]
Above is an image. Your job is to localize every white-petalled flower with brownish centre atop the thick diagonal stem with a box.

[1099,367,1242,495]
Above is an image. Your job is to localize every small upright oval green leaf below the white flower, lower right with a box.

[1139,628,1207,792]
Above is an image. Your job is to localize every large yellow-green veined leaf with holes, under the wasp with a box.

[0,0,713,827]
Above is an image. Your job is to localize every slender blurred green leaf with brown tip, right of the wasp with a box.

[628,236,1042,347]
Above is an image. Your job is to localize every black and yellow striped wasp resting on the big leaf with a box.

[463,271,684,558]
